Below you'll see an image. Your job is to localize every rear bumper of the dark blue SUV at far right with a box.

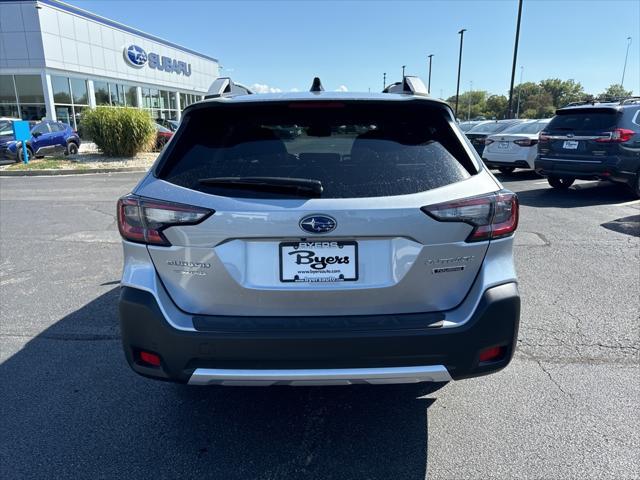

[535,157,636,185]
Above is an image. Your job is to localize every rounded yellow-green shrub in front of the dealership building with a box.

[80,107,156,157]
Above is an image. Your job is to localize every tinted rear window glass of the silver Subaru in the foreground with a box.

[158,102,476,198]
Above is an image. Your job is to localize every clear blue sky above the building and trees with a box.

[66,0,640,98]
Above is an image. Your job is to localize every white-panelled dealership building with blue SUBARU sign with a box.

[0,0,220,128]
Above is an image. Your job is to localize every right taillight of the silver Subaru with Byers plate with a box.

[422,190,518,242]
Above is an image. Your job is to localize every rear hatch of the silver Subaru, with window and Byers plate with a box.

[127,99,515,316]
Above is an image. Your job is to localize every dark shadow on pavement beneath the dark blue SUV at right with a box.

[518,182,634,208]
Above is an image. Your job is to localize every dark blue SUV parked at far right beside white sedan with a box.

[535,97,640,197]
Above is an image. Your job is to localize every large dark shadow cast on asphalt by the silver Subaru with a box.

[0,288,443,480]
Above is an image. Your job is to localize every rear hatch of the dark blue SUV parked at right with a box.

[538,107,620,171]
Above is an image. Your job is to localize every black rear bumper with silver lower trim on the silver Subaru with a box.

[120,283,520,385]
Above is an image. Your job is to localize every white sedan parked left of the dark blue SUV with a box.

[482,118,551,173]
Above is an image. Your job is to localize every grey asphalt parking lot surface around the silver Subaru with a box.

[0,172,640,479]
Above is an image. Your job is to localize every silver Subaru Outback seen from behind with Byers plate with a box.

[118,77,520,385]
